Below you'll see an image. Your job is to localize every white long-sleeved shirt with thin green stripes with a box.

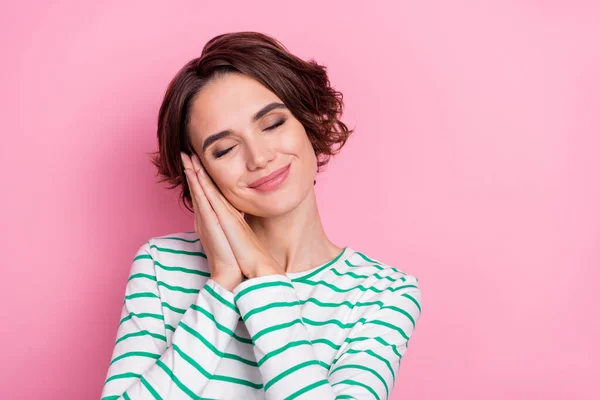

[101,232,421,400]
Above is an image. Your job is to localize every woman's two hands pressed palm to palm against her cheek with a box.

[181,153,285,286]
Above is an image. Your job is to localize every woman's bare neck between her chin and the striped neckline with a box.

[244,188,343,272]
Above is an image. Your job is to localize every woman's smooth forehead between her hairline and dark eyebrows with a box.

[190,73,281,139]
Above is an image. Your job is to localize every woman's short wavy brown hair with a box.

[151,32,353,212]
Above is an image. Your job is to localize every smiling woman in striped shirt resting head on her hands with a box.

[102,32,421,400]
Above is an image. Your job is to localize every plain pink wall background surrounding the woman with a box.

[0,0,600,399]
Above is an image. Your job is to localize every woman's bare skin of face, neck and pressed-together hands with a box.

[182,73,343,290]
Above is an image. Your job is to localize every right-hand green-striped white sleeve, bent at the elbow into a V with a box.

[233,275,421,400]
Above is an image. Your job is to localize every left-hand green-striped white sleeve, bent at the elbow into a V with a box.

[101,243,240,400]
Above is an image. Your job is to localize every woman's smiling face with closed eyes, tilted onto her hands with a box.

[189,73,317,217]
